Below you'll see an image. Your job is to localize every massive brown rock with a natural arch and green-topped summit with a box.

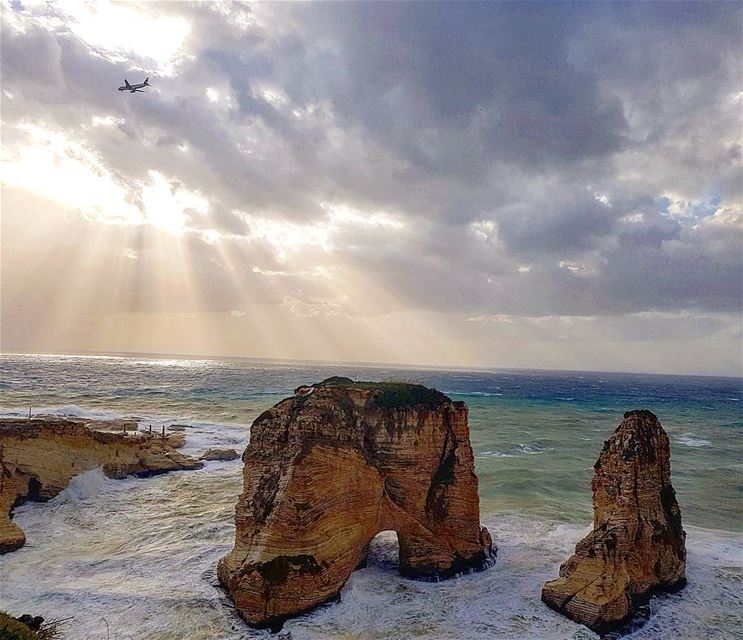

[218,378,495,626]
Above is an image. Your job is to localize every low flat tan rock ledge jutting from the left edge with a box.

[0,418,203,553]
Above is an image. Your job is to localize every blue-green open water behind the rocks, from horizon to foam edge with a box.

[0,356,743,531]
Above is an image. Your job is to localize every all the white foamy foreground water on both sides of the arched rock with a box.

[2,480,743,640]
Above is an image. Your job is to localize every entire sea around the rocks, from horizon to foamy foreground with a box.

[0,354,743,640]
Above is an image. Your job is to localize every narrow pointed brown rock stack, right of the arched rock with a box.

[542,411,686,633]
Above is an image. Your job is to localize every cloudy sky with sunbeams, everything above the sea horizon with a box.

[0,0,743,375]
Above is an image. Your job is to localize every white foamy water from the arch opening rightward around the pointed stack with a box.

[287,516,743,640]
